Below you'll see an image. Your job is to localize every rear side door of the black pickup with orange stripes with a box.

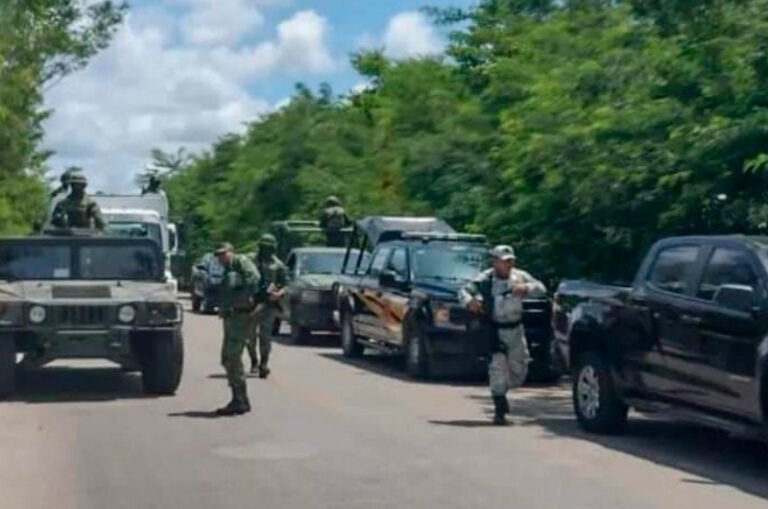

[354,246,392,341]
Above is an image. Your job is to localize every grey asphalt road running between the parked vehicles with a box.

[0,298,768,509]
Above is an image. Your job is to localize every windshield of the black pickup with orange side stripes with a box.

[411,243,488,281]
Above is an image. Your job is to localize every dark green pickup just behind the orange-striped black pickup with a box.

[283,247,368,344]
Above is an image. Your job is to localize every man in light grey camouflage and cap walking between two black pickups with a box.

[459,245,547,425]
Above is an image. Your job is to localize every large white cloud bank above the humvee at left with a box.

[46,0,336,192]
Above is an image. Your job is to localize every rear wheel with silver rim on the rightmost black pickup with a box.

[573,352,629,435]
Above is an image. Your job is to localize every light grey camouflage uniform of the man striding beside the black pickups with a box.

[459,246,547,424]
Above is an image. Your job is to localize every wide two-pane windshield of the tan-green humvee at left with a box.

[0,239,163,281]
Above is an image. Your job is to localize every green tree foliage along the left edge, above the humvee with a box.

[0,0,125,233]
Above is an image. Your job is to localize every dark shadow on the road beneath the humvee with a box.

[12,367,152,403]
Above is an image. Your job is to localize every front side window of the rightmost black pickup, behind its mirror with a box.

[696,247,758,300]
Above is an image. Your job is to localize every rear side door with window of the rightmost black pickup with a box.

[640,244,704,401]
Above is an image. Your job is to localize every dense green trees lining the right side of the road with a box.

[168,0,768,278]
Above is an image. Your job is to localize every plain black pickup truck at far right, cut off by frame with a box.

[553,236,768,438]
